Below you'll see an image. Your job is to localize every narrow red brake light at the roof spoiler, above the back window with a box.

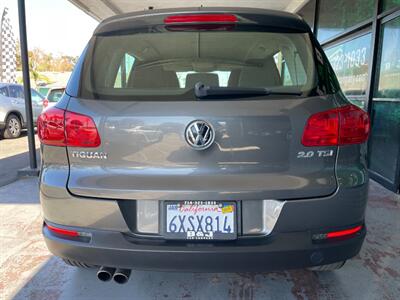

[164,14,238,24]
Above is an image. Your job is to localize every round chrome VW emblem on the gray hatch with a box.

[185,120,215,150]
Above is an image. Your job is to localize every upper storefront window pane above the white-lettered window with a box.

[317,0,376,42]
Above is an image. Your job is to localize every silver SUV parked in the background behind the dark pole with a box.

[0,83,44,139]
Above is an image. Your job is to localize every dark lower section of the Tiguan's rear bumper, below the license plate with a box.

[43,226,366,272]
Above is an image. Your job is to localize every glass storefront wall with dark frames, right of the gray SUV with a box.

[298,0,400,192]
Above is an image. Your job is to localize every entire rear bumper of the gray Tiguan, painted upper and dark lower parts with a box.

[40,146,368,272]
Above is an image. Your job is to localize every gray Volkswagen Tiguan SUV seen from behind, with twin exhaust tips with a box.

[38,8,369,283]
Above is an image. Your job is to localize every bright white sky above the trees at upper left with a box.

[0,0,98,56]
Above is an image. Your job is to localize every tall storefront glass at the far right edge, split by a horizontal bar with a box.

[369,17,400,183]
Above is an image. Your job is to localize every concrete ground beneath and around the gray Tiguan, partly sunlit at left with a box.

[0,178,400,300]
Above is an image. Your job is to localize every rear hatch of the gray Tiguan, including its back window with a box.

[67,15,337,200]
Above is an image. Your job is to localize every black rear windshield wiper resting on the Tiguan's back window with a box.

[194,82,302,99]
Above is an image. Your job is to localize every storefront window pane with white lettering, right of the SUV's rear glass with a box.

[325,33,371,109]
